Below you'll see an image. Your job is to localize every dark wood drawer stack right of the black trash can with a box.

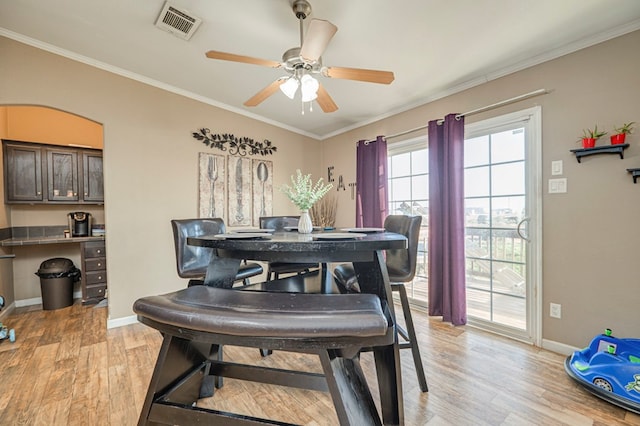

[80,241,107,304]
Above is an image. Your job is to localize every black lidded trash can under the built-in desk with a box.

[36,257,80,311]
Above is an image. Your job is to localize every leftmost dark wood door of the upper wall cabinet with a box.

[3,143,44,203]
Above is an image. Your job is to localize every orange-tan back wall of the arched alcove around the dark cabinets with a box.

[0,105,105,314]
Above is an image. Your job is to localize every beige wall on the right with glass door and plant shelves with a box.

[324,31,640,347]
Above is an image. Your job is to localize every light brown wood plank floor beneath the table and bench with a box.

[0,304,640,426]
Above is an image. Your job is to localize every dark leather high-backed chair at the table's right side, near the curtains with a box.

[333,215,429,392]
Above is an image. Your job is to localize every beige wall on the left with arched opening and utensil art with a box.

[0,38,324,320]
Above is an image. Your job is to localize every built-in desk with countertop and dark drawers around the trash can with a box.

[0,236,107,304]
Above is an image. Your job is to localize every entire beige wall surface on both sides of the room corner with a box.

[0,28,640,346]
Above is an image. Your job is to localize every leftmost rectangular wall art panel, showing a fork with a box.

[198,152,227,219]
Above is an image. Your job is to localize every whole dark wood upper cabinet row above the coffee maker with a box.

[2,140,104,204]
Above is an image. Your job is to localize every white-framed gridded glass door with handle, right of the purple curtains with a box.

[464,108,541,344]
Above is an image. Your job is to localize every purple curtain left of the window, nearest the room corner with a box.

[356,136,389,228]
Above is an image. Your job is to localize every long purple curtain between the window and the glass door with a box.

[429,114,467,325]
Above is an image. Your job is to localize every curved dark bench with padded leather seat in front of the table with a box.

[133,286,395,426]
